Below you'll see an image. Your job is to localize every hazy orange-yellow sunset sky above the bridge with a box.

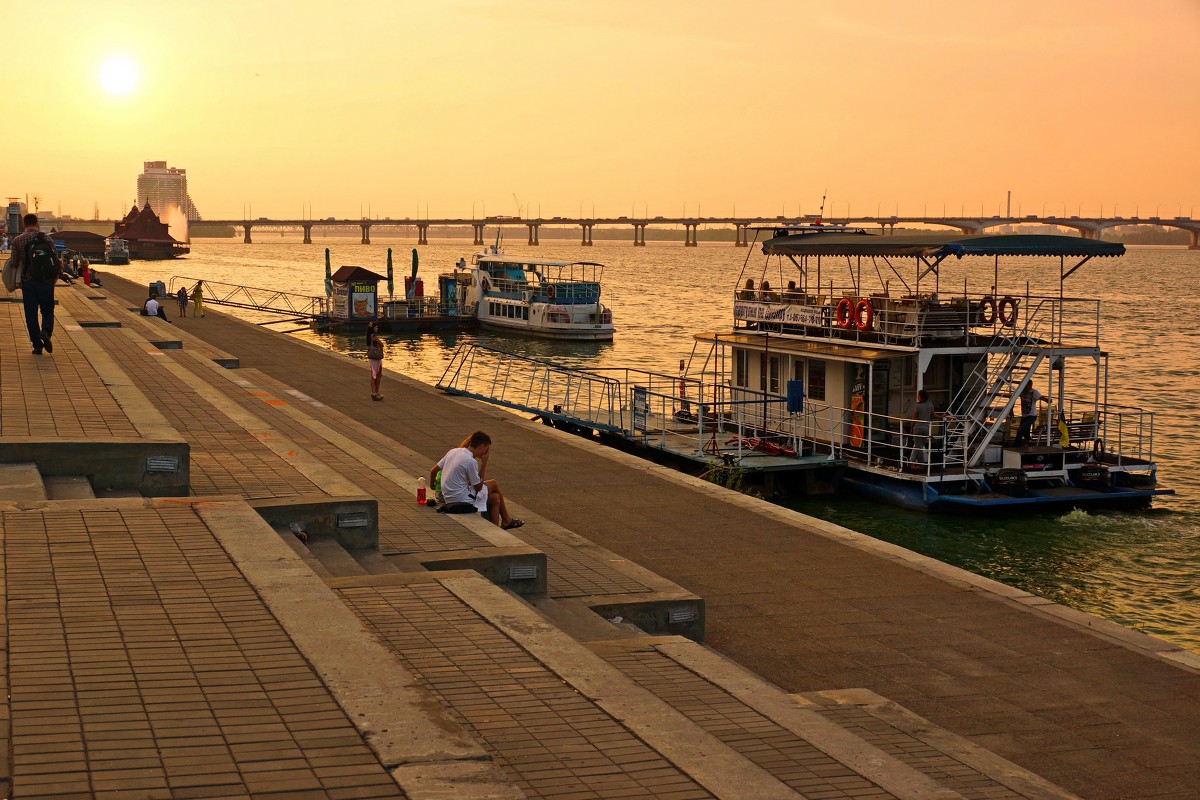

[9,0,1200,218]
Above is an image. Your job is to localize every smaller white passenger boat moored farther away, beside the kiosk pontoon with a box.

[458,246,613,339]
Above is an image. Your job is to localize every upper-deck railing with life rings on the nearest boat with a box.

[733,287,1099,347]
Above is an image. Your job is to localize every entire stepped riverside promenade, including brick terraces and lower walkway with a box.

[0,276,1200,800]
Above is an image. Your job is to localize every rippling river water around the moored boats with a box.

[108,234,1200,652]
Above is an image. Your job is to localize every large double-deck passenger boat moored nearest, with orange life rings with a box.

[694,224,1172,510]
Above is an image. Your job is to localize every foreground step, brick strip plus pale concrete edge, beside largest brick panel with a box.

[331,571,883,800]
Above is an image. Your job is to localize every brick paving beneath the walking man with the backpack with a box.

[0,302,138,438]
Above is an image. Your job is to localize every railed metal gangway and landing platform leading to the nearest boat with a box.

[437,344,845,493]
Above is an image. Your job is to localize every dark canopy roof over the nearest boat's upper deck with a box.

[762,230,1126,258]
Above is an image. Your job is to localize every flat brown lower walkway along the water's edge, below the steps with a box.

[91,279,1200,800]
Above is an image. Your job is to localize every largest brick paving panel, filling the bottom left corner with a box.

[0,504,404,800]
